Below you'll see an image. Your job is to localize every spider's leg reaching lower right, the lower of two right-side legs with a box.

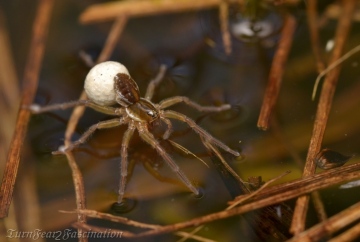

[160,110,240,156]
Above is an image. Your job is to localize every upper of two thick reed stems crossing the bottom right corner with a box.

[288,202,360,242]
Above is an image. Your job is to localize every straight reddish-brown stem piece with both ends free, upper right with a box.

[257,14,296,130]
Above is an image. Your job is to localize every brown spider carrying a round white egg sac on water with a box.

[30,61,240,204]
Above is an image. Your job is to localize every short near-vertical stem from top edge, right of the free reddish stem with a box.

[306,0,325,73]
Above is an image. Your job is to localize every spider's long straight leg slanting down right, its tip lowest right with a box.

[137,124,199,195]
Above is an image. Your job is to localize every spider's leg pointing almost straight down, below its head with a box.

[118,123,135,203]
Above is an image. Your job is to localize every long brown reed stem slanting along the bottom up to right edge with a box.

[76,163,360,237]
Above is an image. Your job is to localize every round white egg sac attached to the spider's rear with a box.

[84,61,129,106]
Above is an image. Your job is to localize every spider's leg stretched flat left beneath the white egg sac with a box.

[27,100,119,116]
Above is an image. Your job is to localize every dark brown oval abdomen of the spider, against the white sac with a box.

[114,73,140,107]
